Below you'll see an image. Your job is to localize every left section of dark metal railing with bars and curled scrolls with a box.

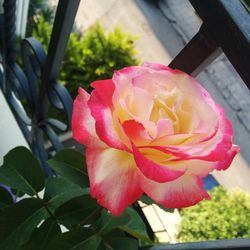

[0,0,79,175]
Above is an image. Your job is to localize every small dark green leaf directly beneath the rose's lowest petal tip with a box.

[99,210,130,235]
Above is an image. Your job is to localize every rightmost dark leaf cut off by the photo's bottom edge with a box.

[105,237,138,250]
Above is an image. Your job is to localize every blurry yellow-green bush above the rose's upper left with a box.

[65,23,138,93]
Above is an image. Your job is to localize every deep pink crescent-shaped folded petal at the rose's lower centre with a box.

[131,142,185,182]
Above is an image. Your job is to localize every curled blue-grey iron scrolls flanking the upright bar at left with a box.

[21,38,72,144]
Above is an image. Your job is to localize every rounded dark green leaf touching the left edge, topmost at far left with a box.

[0,147,45,195]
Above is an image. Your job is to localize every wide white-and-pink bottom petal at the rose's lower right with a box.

[141,174,210,208]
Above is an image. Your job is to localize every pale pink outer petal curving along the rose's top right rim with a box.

[139,63,217,133]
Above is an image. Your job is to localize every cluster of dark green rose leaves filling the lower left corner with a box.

[0,147,151,250]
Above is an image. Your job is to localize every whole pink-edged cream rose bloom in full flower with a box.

[72,63,239,215]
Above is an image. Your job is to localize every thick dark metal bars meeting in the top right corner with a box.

[169,0,250,89]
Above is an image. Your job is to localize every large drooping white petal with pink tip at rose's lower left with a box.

[86,148,143,215]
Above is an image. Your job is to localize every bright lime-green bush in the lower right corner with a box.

[178,187,250,242]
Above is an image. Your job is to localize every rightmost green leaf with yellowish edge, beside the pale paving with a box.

[119,207,152,243]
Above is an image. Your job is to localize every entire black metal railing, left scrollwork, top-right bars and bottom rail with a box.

[0,0,250,247]
